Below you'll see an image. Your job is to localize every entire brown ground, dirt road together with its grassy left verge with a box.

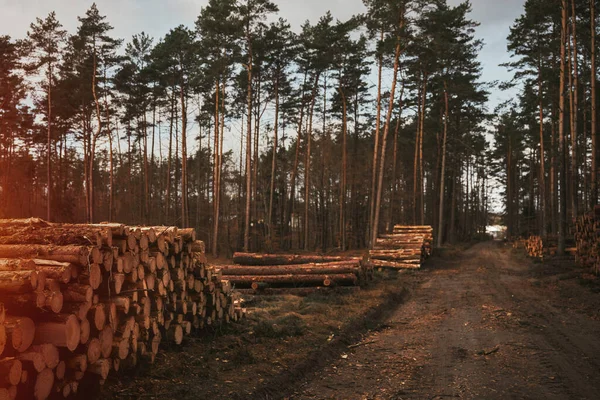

[99,242,600,400]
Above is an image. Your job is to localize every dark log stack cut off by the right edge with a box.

[575,206,600,274]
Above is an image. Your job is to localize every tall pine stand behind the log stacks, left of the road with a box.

[0,0,488,255]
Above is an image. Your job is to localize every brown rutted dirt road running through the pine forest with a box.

[290,242,600,399]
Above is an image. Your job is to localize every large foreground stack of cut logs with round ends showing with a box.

[0,219,244,400]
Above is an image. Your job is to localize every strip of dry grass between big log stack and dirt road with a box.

[99,271,413,400]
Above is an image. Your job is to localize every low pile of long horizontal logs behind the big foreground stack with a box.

[223,253,373,295]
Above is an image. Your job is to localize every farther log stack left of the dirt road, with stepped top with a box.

[369,225,433,269]
